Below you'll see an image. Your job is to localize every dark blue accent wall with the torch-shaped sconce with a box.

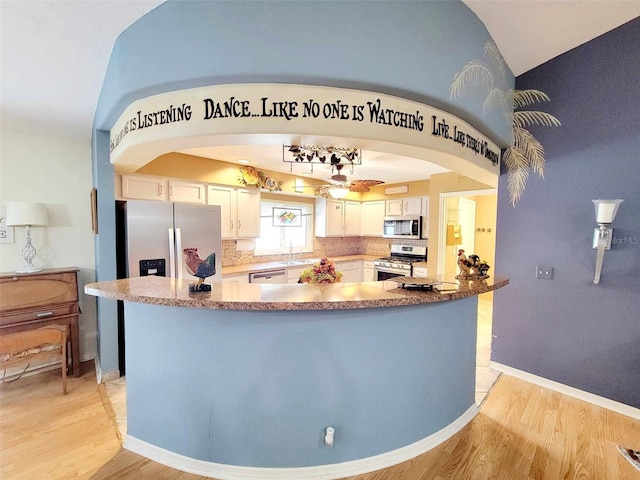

[492,19,640,407]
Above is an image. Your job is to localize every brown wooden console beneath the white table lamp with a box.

[0,268,80,377]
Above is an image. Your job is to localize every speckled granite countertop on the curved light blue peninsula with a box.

[84,276,509,310]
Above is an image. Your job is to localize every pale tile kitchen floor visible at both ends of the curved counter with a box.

[105,298,499,439]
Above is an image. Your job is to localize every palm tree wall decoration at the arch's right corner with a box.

[450,42,560,207]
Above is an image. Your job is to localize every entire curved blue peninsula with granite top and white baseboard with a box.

[85,277,508,479]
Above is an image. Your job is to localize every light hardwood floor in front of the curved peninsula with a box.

[0,363,640,480]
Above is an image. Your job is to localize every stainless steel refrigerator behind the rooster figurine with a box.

[125,200,222,284]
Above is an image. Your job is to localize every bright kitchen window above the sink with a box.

[254,200,313,255]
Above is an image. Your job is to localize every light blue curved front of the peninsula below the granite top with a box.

[125,296,477,468]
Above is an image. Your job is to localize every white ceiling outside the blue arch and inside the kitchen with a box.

[0,0,640,183]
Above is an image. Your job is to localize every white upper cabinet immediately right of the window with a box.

[315,197,360,237]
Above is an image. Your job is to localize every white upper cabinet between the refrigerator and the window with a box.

[207,185,260,239]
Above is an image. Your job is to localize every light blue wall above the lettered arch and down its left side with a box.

[93,0,514,372]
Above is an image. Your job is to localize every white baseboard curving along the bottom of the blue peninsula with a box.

[123,404,478,480]
